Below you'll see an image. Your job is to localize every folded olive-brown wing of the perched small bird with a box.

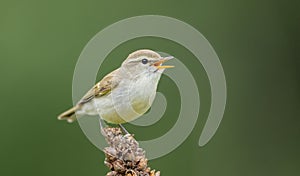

[78,69,120,104]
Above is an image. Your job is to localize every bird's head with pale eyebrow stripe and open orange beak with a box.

[122,49,174,76]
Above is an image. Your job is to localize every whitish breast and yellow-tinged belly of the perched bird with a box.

[79,75,158,123]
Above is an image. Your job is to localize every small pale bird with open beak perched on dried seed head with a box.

[58,49,174,125]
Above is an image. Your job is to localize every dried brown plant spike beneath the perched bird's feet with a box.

[102,127,160,176]
